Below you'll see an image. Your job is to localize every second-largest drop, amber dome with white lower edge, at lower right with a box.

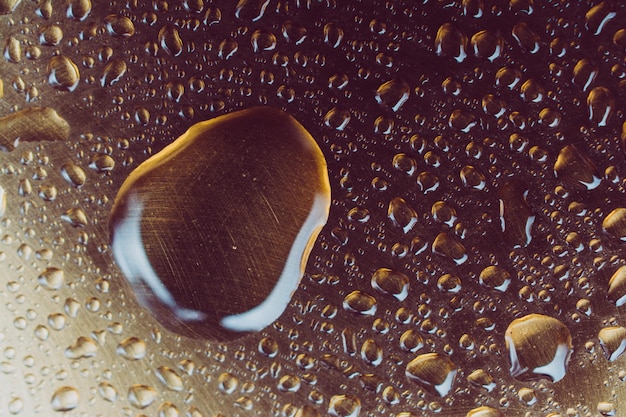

[505,314,573,382]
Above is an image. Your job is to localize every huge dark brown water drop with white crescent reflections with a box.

[110,107,330,340]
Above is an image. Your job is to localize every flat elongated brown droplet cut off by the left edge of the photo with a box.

[0,107,70,152]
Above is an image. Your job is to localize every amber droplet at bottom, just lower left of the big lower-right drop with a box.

[405,353,457,397]
